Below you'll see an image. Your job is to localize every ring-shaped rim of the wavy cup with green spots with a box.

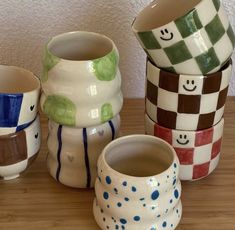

[45,30,119,63]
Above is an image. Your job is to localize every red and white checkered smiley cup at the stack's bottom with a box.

[145,115,224,180]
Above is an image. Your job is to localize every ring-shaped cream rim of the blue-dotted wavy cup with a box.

[98,134,179,180]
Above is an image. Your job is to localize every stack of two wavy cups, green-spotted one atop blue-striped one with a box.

[40,31,123,188]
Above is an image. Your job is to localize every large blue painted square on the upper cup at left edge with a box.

[0,94,23,127]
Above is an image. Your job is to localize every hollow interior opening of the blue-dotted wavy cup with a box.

[105,135,174,177]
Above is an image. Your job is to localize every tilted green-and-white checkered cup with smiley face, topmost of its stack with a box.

[132,0,235,75]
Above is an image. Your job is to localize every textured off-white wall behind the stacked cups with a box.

[0,0,235,97]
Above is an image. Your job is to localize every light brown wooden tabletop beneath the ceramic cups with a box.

[0,98,235,230]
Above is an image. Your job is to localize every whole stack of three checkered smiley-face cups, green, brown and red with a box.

[132,0,235,180]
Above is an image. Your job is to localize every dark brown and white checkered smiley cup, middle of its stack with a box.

[145,61,232,130]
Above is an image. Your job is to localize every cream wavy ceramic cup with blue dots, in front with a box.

[93,135,182,230]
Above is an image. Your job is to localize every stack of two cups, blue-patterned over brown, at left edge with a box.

[0,65,41,180]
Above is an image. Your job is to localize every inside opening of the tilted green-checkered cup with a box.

[133,0,203,32]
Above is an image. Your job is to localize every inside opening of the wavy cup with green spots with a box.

[47,31,113,61]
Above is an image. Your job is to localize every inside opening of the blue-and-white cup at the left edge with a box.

[0,65,40,94]
